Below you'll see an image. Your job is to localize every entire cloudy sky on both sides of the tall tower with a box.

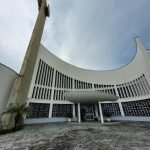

[0,0,150,72]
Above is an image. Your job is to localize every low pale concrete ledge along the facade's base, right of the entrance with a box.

[111,117,150,121]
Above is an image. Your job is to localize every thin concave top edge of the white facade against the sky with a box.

[41,36,139,72]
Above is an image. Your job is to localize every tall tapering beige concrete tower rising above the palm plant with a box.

[9,0,49,103]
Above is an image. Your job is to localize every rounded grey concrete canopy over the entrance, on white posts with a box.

[64,91,119,103]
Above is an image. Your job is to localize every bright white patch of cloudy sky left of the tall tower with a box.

[0,0,37,72]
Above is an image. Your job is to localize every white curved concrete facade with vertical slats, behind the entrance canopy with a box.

[0,37,150,123]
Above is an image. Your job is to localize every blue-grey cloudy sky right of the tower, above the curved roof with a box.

[43,0,150,70]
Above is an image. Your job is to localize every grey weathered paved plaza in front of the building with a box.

[0,122,150,150]
